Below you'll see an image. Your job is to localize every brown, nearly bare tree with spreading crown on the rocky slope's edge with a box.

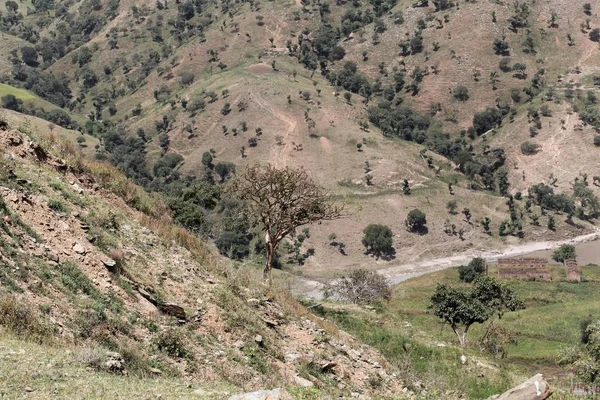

[232,164,343,285]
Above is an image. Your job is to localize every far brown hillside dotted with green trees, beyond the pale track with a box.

[0,0,600,277]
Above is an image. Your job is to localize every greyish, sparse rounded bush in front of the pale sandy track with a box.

[324,269,392,304]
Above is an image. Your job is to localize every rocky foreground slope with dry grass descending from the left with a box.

[0,123,402,398]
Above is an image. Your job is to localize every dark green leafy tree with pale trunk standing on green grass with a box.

[428,276,524,346]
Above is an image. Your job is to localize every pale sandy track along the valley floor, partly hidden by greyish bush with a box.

[293,229,600,299]
